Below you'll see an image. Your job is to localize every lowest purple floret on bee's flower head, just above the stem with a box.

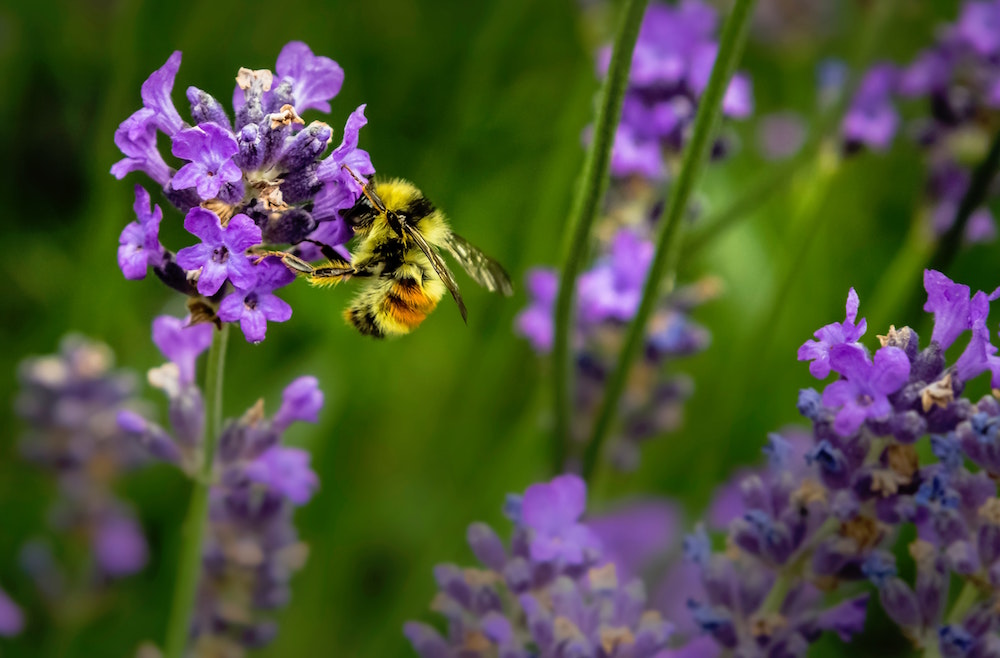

[219,255,295,343]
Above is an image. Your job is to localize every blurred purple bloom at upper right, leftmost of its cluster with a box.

[841,64,899,151]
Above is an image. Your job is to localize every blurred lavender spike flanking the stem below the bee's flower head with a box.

[117,316,323,655]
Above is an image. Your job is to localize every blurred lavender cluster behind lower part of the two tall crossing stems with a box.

[515,228,717,469]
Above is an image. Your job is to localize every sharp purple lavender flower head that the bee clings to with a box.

[111,41,374,343]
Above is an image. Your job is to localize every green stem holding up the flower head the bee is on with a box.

[164,324,229,658]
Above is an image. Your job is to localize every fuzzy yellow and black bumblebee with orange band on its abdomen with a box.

[264,166,513,338]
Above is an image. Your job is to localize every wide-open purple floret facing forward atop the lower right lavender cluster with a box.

[823,344,910,436]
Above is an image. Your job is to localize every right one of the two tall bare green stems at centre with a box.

[580,0,756,479]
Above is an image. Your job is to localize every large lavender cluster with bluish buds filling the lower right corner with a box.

[672,270,1000,658]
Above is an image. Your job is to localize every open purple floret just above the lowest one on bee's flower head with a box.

[177,206,261,295]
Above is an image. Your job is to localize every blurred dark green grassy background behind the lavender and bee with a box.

[0,0,1000,657]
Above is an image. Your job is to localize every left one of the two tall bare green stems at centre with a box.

[552,0,649,473]
